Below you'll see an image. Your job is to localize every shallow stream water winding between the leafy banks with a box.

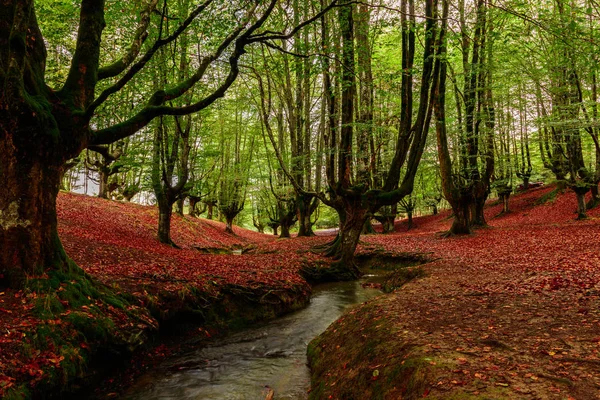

[123,276,381,400]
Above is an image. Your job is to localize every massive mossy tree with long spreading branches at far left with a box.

[0,0,336,288]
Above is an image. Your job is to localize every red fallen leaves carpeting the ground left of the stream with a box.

[0,193,322,398]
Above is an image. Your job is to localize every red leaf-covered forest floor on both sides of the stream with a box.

[0,188,600,399]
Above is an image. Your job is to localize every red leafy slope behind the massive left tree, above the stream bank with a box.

[58,194,324,291]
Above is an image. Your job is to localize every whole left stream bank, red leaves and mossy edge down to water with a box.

[0,193,327,398]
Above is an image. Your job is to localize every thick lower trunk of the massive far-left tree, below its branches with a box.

[0,152,79,289]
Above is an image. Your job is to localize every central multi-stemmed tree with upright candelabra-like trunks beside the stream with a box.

[259,0,446,279]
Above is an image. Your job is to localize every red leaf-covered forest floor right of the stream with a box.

[309,187,600,399]
